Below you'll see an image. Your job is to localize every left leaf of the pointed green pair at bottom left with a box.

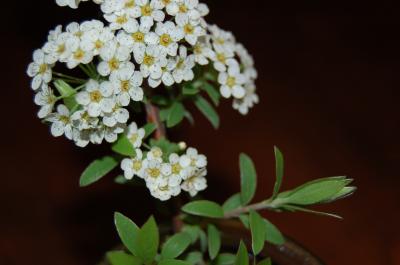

[114,212,140,256]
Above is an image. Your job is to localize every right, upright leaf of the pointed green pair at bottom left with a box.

[136,216,160,264]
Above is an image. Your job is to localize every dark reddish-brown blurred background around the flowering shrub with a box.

[0,0,400,265]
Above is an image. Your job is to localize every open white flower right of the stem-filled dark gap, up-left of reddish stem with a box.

[110,64,143,106]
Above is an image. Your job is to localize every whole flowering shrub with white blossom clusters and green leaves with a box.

[27,0,354,265]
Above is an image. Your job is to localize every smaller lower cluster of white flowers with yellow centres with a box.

[121,123,207,201]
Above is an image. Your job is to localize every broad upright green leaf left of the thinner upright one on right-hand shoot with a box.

[239,153,257,205]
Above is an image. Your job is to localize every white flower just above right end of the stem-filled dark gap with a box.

[97,41,131,76]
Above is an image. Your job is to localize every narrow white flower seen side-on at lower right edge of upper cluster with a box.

[172,46,195,83]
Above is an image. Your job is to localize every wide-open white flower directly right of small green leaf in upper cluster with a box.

[76,80,116,117]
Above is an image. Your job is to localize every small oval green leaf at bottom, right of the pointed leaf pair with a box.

[161,232,191,259]
